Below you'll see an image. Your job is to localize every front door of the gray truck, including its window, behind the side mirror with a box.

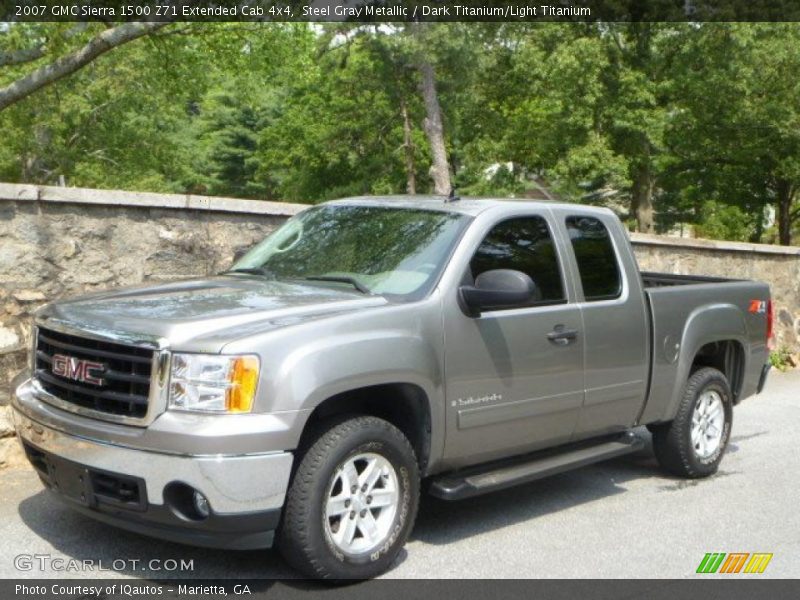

[444,215,584,467]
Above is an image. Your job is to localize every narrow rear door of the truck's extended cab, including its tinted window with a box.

[555,208,650,439]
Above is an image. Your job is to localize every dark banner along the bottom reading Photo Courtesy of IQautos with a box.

[0,579,798,600]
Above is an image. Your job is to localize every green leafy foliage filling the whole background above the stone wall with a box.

[0,23,800,243]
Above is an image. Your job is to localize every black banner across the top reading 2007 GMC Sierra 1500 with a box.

[0,0,800,23]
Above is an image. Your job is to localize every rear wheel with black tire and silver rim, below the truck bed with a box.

[652,367,733,479]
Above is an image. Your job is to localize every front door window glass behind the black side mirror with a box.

[470,217,566,304]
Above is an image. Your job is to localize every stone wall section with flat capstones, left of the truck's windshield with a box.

[0,184,305,404]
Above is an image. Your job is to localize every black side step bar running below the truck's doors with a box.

[429,433,644,500]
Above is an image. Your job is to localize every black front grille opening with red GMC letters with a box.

[36,328,153,418]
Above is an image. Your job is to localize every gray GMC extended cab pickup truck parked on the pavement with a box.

[13,197,772,579]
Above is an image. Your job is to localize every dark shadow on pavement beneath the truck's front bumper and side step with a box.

[18,432,669,576]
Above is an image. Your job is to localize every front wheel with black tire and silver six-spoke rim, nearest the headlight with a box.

[278,416,420,580]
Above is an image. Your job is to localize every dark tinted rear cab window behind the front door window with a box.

[566,216,622,302]
